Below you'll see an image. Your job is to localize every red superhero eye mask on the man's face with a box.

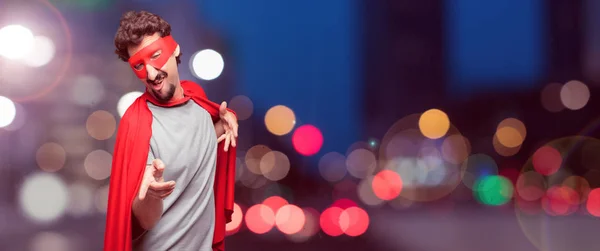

[129,36,177,79]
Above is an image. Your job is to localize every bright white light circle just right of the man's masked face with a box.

[191,49,225,80]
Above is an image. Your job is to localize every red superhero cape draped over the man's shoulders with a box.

[104,81,236,251]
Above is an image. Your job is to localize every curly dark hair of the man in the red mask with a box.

[115,11,182,64]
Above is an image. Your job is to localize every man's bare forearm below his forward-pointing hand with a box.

[132,196,163,230]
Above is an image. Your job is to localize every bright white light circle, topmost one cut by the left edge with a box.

[0,24,35,59]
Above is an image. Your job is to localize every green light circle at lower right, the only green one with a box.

[473,175,514,206]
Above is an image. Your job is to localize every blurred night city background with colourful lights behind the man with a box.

[0,0,600,251]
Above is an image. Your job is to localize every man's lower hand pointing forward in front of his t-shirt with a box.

[139,159,175,201]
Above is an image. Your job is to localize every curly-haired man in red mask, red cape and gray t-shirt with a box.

[104,11,238,251]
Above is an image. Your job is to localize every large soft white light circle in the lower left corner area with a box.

[19,173,69,223]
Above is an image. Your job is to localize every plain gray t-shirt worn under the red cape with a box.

[133,100,217,251]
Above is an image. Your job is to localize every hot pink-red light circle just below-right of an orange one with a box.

[292,125,323,156]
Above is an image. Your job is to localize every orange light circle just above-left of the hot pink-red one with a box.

[265,105,296,136]
